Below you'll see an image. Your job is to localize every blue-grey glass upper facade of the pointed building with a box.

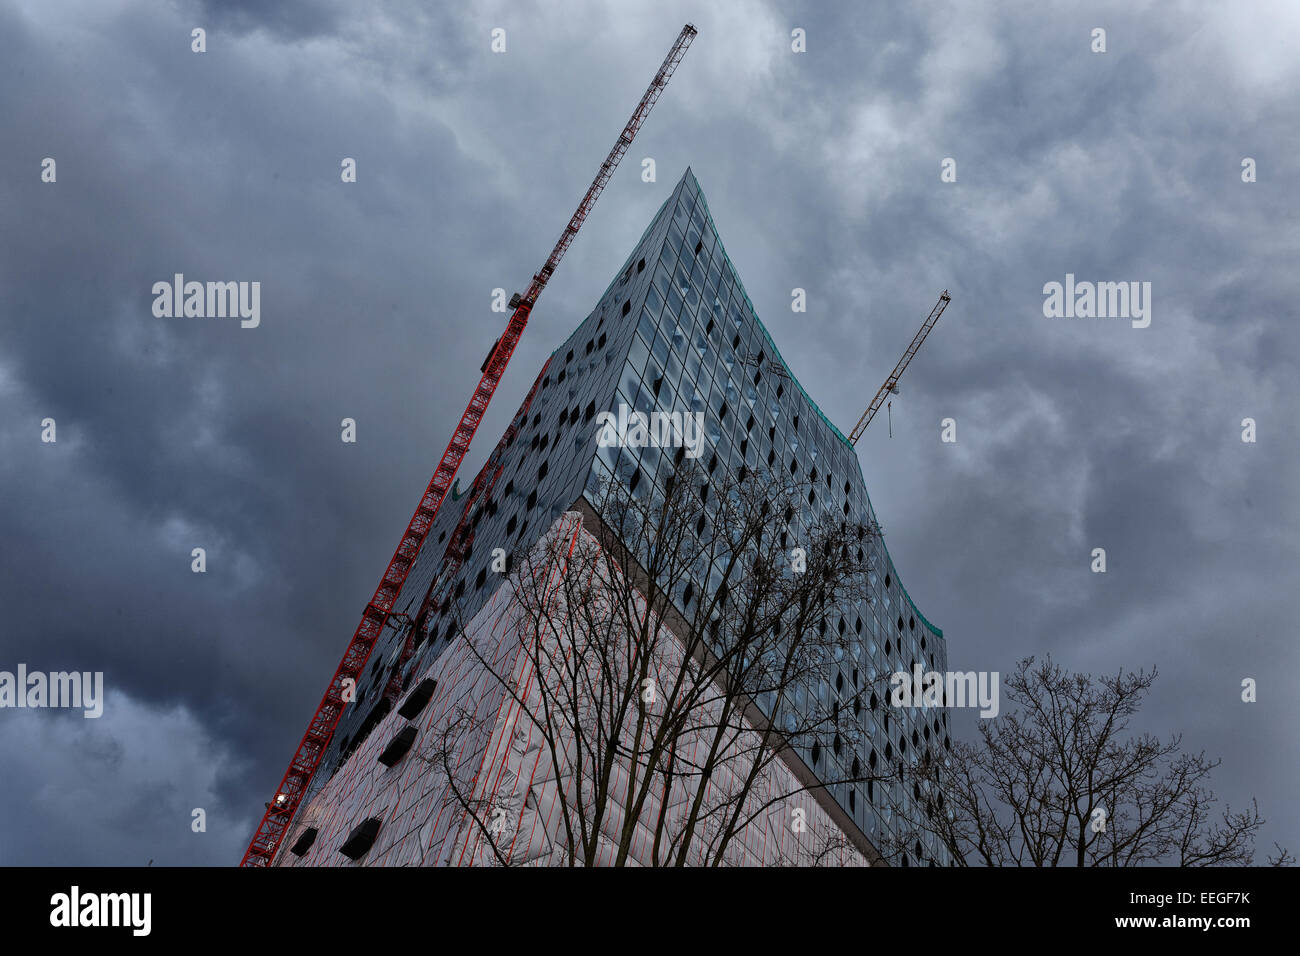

[317,169,949,865]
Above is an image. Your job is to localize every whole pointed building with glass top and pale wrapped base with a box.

[284,169,950,865]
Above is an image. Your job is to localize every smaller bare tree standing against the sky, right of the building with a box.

[902,657,1290,866]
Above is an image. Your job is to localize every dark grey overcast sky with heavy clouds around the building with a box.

[0,0,1300,865]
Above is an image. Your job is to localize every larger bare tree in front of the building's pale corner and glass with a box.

[410,454,920,866]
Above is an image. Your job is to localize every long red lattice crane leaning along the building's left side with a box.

[239,23,697,866]
